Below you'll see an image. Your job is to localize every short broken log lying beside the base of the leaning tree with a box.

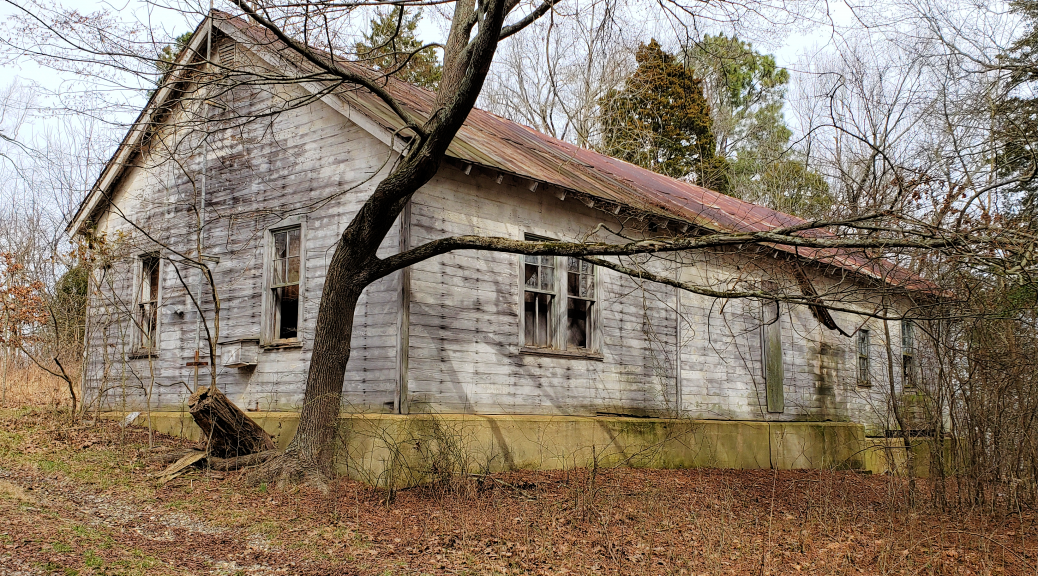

[188,386,274,458]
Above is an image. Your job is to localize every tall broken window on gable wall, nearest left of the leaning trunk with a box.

[268,226,302,341]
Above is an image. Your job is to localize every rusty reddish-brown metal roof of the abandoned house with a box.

[172,15,935,292]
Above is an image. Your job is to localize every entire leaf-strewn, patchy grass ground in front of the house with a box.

[0,409,1038,575]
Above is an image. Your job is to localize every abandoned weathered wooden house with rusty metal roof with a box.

[69,12,923,475]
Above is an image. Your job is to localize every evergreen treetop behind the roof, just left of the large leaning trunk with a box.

[354,6,442,90]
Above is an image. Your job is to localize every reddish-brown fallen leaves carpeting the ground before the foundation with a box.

[0,408,1038,575]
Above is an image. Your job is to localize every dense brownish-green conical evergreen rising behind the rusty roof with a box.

[600,39,727,192]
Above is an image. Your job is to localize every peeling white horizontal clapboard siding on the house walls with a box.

[85,37,900,431]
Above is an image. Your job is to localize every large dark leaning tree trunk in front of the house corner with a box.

[246,0,510,485]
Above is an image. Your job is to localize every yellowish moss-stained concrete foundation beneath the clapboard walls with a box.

[108,412,917,486]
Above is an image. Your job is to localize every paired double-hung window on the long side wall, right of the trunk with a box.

[518,234,602,359]
